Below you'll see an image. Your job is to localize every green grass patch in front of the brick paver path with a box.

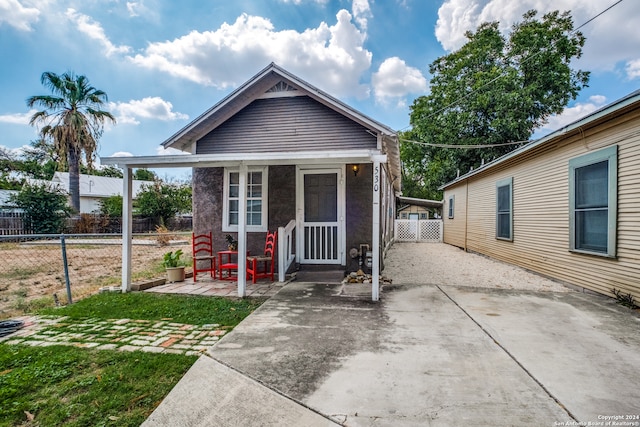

[0,345,197,426]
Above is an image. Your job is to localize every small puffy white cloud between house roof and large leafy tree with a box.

[371,57,427,103]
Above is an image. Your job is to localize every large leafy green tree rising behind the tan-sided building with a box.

[400,10,589,198]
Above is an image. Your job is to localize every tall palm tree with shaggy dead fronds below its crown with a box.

[27,71,116,216]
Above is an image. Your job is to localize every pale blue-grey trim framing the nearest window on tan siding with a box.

[569,145,618,258]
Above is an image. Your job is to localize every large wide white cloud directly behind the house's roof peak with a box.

[130,10,372,98]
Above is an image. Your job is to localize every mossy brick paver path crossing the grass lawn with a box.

[0,316,226,355]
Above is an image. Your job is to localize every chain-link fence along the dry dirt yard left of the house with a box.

[0,232,191,319]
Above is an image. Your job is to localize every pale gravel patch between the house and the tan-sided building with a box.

[382,243,571,292]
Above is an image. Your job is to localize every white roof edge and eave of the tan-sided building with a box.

[439,90,640,190]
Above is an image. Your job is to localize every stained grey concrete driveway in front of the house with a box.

[145,246,640,426]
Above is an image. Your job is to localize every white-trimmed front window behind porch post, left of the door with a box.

[222,167,268,231]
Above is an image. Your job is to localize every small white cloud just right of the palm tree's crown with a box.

[109,96,189,125]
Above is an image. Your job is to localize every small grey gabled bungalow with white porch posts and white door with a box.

[101,63,401,300]
